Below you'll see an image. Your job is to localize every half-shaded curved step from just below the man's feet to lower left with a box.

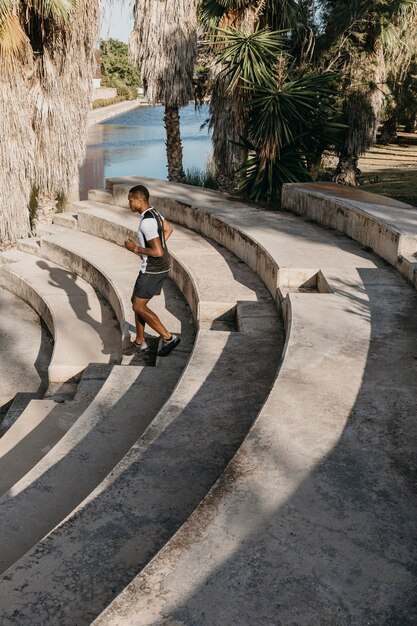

[0,356,184,571]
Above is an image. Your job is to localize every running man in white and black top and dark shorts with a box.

[125,185,181,356]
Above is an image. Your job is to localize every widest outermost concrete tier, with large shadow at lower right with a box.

[82,180,417,626]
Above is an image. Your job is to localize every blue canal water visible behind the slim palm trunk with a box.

[80,105,212,199]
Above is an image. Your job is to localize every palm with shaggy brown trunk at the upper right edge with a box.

[321,0,417,185]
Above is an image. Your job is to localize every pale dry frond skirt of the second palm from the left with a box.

[30,0,98,196]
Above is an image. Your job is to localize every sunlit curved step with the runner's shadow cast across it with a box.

[0,251,121,382]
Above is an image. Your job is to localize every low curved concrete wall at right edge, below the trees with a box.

[282,183,417,267]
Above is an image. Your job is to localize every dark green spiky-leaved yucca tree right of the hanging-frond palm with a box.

[211,22,340,203]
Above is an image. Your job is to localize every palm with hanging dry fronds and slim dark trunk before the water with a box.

[129,0,198,182]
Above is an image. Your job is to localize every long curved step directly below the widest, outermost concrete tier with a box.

[0,203,283,624]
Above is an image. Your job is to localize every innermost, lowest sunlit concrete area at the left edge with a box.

[0,288,51,407]
